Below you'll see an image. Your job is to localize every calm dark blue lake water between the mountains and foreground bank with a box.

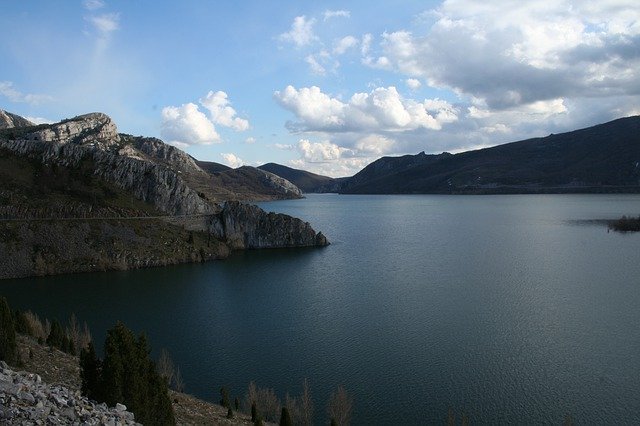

[0,195,640,425]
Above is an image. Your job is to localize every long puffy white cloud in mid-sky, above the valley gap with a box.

[274,86,457,132]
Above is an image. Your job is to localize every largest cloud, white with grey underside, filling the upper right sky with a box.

[364,0,640,109]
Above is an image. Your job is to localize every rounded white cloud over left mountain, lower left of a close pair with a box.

[161,102,220,148]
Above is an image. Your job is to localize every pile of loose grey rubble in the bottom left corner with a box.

[0,361,139,425]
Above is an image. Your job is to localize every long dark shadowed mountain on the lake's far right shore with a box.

[338,116,640,194]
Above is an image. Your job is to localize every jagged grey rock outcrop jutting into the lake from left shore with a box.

[209,201,329,250]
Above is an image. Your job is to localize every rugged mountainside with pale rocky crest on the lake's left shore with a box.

[0,110,328,278]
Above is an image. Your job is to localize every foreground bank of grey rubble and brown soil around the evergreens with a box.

[0,336,266,426]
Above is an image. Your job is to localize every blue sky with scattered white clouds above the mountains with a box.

[0,0,640,177]
